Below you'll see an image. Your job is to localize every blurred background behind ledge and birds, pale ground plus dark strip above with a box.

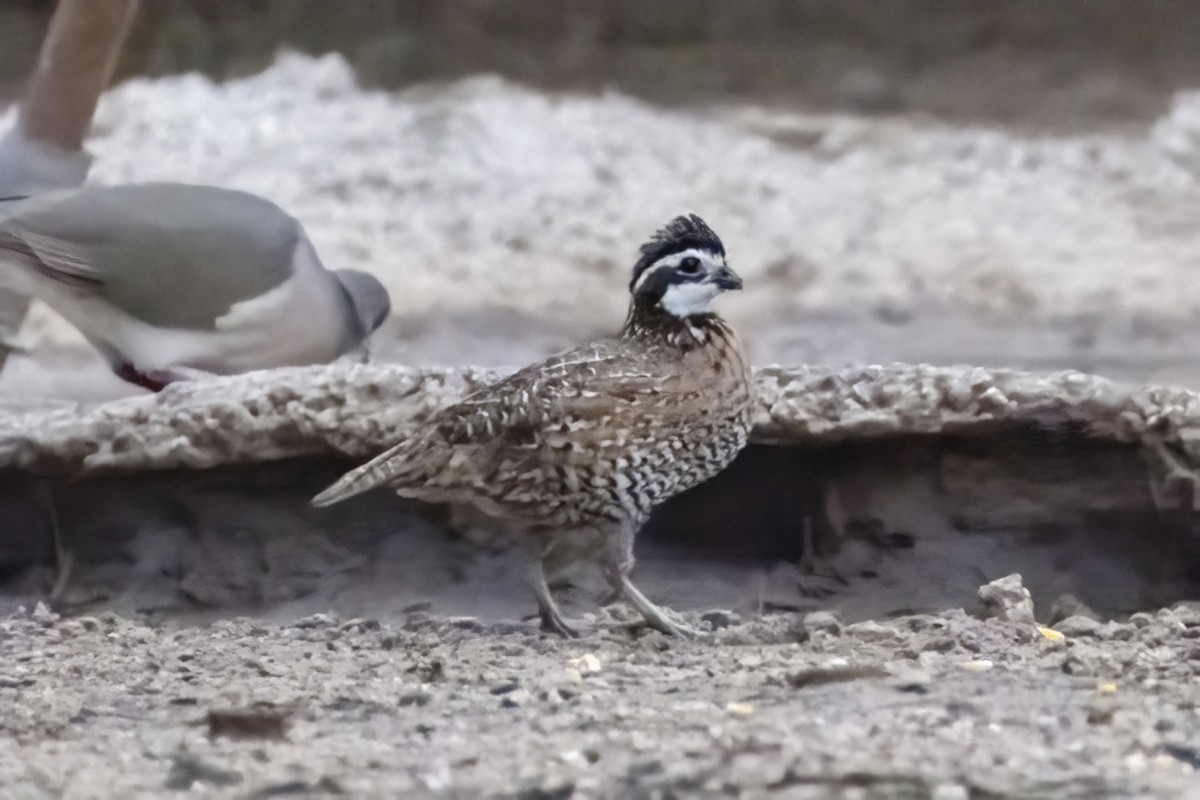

[7,0,1200,397]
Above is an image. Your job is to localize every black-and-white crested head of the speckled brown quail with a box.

[630,215,742,319]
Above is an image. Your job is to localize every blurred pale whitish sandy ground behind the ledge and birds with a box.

[9,55,1200,396]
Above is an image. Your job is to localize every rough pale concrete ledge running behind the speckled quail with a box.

[0,363,1200,476]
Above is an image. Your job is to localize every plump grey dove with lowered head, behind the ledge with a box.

[0,184,390,391]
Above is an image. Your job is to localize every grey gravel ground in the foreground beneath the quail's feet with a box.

[0,584,1200,800]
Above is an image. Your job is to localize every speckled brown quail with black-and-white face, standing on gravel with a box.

[313,215,754,636]
